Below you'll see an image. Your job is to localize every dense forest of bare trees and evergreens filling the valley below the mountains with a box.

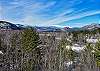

[0,28,100,71]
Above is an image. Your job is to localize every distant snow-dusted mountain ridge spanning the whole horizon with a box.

[0,21,100,32]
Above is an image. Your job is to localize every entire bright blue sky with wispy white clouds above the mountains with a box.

[0,0,100,27]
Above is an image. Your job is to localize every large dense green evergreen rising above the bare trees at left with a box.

[21,28,39,52]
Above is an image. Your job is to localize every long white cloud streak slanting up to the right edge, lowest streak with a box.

[46,11,100,24]
